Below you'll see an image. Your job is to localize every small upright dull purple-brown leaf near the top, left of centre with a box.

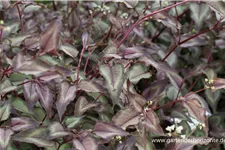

[68,7,81,28]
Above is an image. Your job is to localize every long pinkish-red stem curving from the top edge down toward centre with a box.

[117,0,191,48]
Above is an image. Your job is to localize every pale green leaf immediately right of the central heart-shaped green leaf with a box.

[127,64,152,84]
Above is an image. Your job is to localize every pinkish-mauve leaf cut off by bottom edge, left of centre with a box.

[73,135,98,150]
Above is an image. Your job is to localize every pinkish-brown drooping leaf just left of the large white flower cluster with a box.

[142,110,164,135]
